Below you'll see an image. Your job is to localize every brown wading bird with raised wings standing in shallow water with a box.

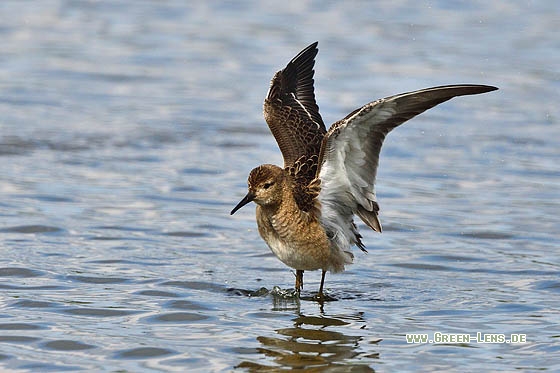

[230,42,498,300]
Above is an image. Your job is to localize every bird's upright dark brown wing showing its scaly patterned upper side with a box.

[263,42,327,171]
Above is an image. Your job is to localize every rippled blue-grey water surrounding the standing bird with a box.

[0,0,560,371]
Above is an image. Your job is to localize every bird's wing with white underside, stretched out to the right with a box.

[318,85,497,247]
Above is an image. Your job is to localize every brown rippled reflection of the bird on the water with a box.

[237,304,380,372]
